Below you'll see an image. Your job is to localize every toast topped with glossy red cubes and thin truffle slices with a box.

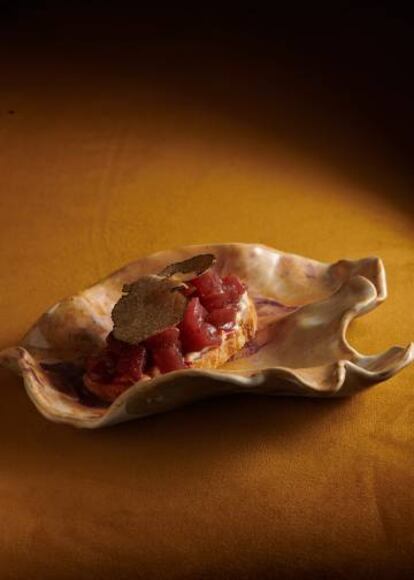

[84,254,257,402]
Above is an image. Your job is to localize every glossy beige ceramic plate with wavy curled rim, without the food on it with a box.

[0,243,414,428]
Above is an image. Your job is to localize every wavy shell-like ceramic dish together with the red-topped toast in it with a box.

[0,243,414,429]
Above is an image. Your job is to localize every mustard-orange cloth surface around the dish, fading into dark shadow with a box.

[0,15,414,580]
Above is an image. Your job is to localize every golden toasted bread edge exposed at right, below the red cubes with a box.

[190,295,257,369]
